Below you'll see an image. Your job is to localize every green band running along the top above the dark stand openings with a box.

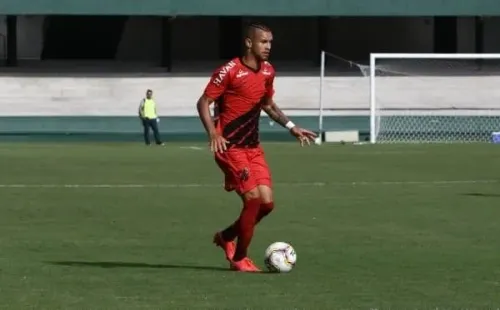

[0,0,500,16]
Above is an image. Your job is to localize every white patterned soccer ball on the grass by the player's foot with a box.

[264,242,297,272]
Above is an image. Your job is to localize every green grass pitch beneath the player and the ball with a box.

[0,143,500,310]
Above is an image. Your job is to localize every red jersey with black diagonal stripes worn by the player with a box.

[205,58,275,147]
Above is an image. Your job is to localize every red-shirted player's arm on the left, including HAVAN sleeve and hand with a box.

[196,65,231,152]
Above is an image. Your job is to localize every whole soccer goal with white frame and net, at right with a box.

[369,53,500,143]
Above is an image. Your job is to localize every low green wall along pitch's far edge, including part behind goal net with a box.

[0,116,494,142]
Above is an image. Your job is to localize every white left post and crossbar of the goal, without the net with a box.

[369,53,500,143]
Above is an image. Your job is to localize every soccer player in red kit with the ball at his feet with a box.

[197,24,316,272]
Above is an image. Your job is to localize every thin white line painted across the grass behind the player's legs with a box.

[0,180,494,189]
